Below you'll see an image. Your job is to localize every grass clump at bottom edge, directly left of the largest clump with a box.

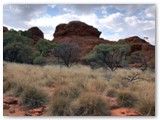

[49,96,72,116]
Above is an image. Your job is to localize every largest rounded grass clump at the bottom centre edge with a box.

[73,93,109,116]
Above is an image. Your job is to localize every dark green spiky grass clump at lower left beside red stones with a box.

[20,86,47,108]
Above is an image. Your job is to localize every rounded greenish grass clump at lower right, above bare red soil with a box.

[117,92,137,107]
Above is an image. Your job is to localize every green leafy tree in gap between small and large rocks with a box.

[36,39,53,57]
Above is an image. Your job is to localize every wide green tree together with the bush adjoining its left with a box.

[84,44,130,71]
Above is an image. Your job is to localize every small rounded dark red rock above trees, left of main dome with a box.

[28,27,44,42]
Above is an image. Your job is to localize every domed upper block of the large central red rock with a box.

[54,21,101,38]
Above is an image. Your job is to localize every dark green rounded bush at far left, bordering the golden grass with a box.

[3,42,32,63]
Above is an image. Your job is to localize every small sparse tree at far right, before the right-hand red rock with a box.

[130,51,148,71]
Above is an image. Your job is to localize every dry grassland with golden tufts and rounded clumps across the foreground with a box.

[3,62,155,116]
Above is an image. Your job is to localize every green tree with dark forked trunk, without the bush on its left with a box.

[95,44,130,71]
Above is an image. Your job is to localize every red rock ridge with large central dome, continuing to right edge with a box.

[52,21,155,64]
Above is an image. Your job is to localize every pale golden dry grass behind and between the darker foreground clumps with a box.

[3,62,155,115]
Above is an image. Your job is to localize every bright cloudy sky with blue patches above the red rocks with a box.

[3,4,156,45]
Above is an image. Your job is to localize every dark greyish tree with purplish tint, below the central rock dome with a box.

[53,43,79,67]
